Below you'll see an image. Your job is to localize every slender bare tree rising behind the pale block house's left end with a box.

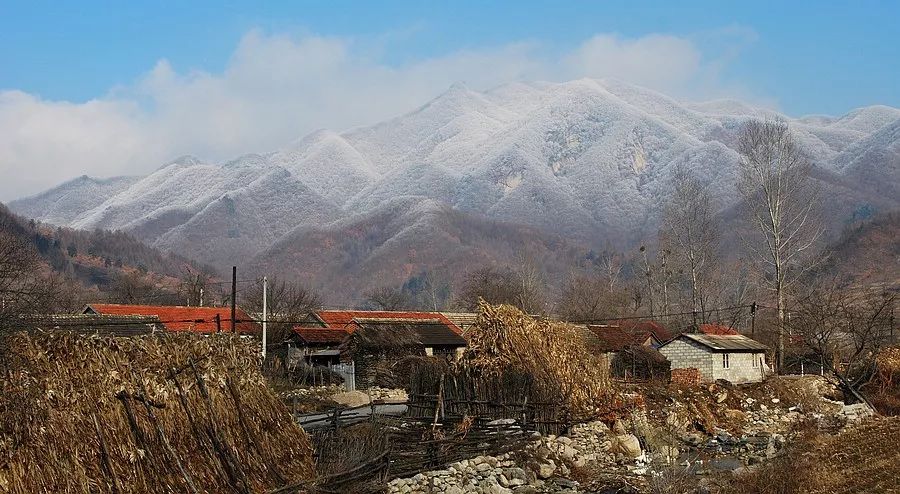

[663,166,719,324]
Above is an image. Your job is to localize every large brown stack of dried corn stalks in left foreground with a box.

[0,331,314,493]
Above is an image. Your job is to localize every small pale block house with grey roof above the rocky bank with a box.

[659,333,769,383]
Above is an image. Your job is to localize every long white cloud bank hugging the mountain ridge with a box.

[0,31,760,200]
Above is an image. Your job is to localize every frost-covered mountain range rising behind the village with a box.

[10,79,900,300]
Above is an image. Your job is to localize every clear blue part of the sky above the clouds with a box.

[0,1,900,115]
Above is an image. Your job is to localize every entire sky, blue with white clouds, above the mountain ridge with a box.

[0,0,900,201]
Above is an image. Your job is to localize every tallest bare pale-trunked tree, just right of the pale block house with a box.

[738,120,823,370]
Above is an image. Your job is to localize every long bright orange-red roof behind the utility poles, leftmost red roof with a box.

[83,304,260,334]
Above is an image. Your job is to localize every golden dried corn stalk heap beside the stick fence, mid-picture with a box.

[460,302,621,421]
